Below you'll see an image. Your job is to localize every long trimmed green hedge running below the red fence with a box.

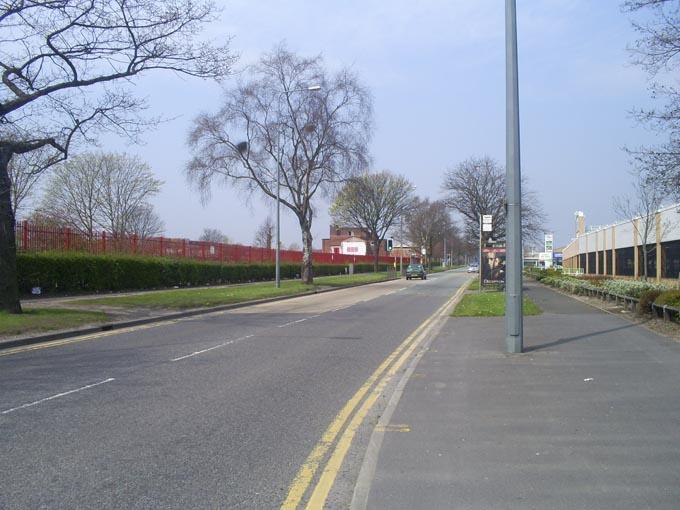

[17,252,394,294]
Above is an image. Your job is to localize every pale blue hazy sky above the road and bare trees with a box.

[87,0,657,251]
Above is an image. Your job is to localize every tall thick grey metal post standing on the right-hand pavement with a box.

[505,0,524,353]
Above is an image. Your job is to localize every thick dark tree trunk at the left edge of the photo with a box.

[0,147,21,313]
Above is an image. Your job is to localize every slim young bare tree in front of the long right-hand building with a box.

[614,173,669,280]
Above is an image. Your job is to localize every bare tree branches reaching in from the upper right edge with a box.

[623,0,680,199]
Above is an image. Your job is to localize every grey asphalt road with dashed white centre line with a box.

[0,272,468,509]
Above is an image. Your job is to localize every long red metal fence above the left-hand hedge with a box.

[16,221,395,264]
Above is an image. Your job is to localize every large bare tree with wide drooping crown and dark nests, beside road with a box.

[187,47,372,284]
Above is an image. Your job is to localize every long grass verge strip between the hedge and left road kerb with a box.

[73,273,388,310]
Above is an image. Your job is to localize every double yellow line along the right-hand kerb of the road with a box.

[281,285,467,510]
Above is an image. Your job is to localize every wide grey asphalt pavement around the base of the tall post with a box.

[368,284,680,510]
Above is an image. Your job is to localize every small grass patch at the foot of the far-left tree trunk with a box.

[0,308,108,336]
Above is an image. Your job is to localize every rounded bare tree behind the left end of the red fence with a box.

[40,152,162,237]
